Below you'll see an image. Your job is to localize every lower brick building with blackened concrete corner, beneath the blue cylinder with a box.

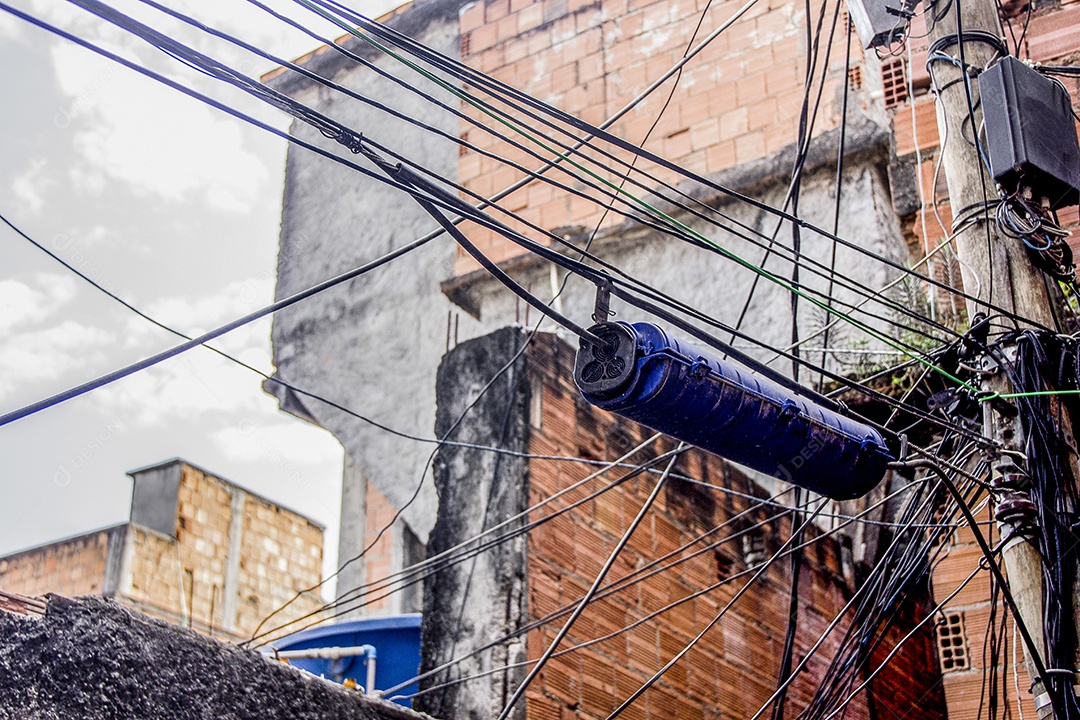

[417,329,944,720]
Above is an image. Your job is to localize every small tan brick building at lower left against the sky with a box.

[0,460,323,639]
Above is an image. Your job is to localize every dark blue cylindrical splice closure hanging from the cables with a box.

[575,323,892,500]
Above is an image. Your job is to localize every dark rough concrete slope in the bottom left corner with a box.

[0,596,427,720]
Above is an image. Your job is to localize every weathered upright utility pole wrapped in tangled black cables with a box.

[927,0,1077,718]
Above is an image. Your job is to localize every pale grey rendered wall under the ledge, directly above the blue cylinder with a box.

[444,113,907,388]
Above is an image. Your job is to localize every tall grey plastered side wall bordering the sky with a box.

[268,0,475,598]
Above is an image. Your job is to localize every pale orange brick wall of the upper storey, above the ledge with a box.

[455,0,859,274]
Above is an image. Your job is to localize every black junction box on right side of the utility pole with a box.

[978,57,1080,209]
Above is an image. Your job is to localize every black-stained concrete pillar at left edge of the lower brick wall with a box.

[416,328,529,720]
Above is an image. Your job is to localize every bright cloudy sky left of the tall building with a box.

[0,0,395,591]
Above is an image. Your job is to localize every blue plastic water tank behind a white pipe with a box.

[273,613,420,707]
